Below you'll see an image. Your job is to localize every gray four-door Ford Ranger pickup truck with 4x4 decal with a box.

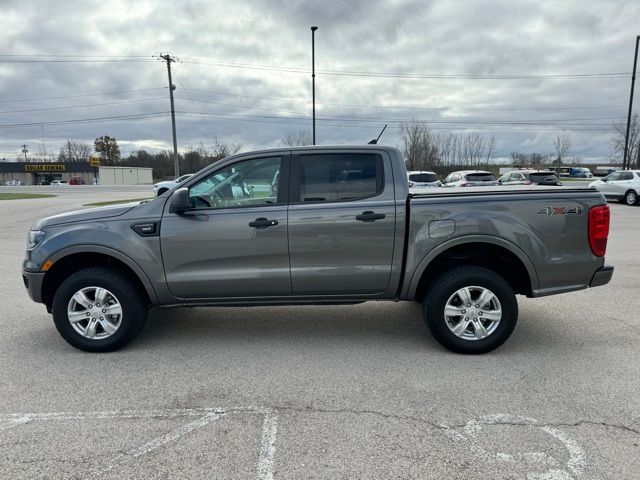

[23,145,613,353]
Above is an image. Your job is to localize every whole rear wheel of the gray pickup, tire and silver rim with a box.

[423,266,518,354]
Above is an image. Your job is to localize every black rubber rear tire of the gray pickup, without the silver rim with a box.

[422,266,518,354]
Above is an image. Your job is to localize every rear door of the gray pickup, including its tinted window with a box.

[289,151,396,296]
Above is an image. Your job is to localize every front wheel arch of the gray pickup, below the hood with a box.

[42,245,158,310]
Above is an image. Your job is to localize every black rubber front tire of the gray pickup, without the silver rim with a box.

[53,267,149,352]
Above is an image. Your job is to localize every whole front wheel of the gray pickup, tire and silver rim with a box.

[53,267,148,352]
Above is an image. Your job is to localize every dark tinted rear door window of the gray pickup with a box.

[300,153,384,203]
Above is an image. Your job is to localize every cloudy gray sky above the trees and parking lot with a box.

[0,0,640,161]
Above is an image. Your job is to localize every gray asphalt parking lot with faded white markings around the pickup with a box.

[0,186,640,480]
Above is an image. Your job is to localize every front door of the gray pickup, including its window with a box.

[160,153,291,299]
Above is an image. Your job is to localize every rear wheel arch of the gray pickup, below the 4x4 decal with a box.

[406,235,538,300]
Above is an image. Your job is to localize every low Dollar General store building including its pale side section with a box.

[0,162,153,185]
